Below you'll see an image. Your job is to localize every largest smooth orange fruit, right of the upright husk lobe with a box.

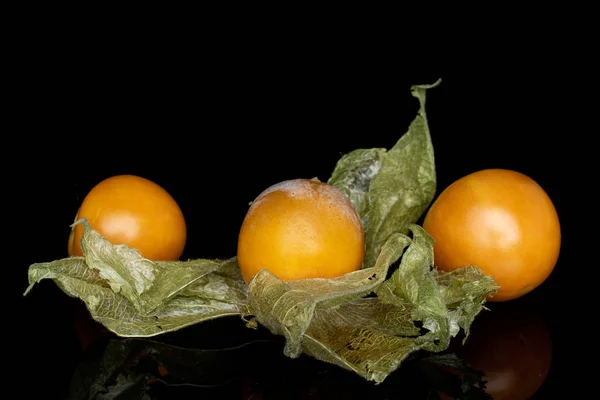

[423,169,561,301]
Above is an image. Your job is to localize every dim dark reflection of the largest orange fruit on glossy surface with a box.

[456,307,552,400]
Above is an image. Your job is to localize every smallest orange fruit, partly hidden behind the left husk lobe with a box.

[69,175,186,260]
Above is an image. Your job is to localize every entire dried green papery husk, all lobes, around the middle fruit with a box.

[26,79,498,382]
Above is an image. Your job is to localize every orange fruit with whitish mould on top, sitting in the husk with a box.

[238,179,364,283]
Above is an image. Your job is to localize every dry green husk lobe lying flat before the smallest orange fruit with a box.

[25,225,248,337]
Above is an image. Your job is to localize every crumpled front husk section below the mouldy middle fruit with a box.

[248,224,497,382]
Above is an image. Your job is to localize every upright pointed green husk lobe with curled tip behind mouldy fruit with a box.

[328,81,439,268]
